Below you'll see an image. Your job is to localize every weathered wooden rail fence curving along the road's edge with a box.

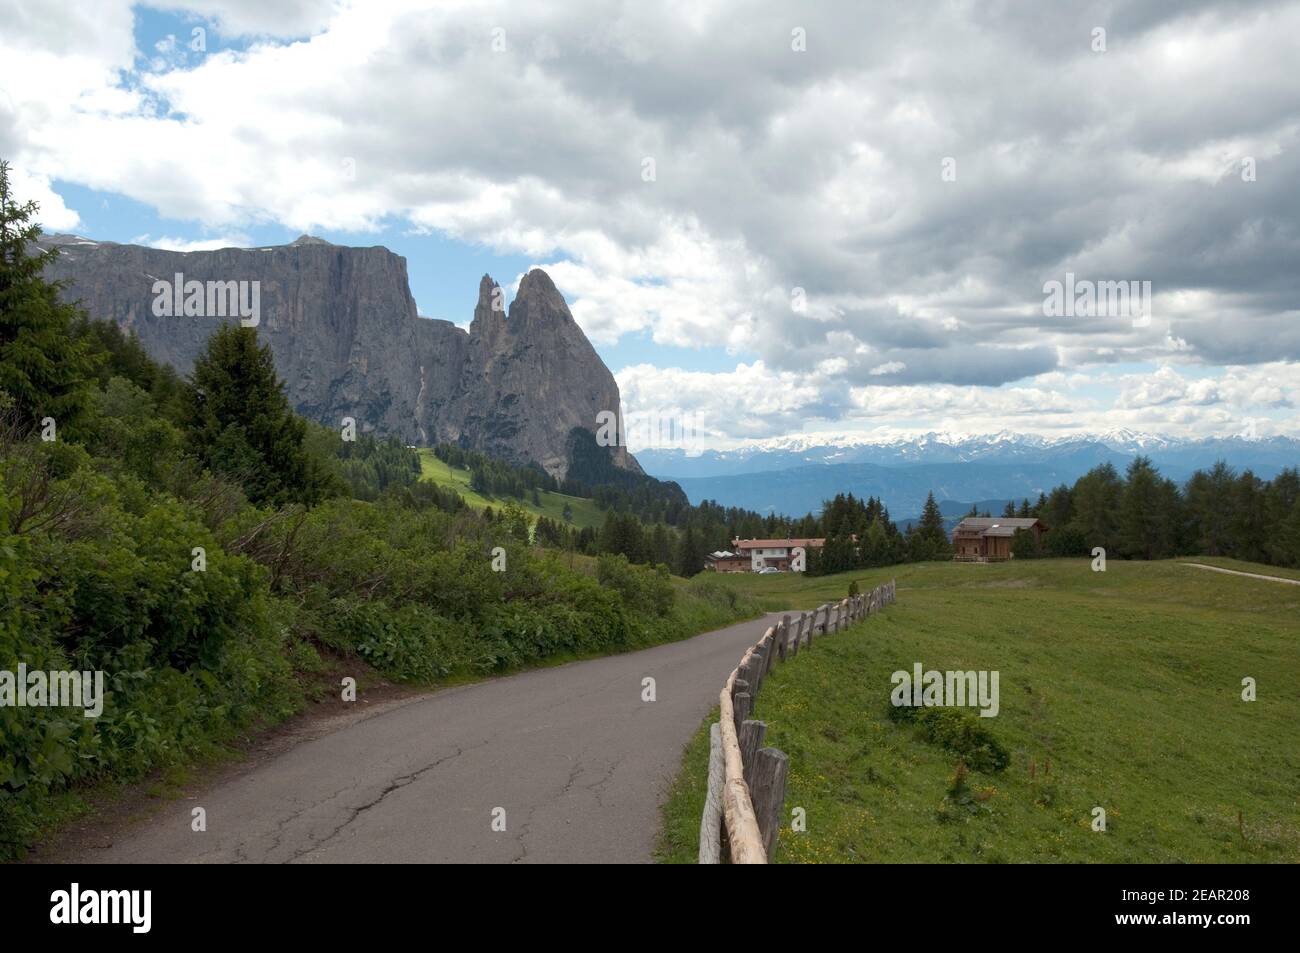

[699,580,896,863]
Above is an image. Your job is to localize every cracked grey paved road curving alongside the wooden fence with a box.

[78,615,779,863]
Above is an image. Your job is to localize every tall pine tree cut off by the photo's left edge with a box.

[0,161,95,433]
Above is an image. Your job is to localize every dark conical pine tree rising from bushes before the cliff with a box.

[182,325,339,506]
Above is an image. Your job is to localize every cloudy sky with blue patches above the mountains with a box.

[0,0,1300,450]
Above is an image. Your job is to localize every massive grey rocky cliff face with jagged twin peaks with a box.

[43,235,641,476]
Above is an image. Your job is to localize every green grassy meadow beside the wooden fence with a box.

[662,560,1300,863]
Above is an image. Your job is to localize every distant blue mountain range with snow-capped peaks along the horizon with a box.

[636,429,1300,516]
